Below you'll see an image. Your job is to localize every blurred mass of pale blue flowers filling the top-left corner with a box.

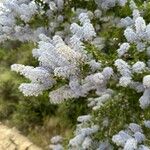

[0,0,44,42]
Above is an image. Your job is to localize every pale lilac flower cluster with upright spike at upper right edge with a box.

[121,8,150,52]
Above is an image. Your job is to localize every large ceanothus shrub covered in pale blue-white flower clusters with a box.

[0,0,150,150]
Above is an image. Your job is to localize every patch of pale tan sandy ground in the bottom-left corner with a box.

[0,123,42,150]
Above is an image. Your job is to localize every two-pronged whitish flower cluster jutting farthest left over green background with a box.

[11,64,56,96]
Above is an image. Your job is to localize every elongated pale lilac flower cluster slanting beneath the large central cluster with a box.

[49,67,113,103]
